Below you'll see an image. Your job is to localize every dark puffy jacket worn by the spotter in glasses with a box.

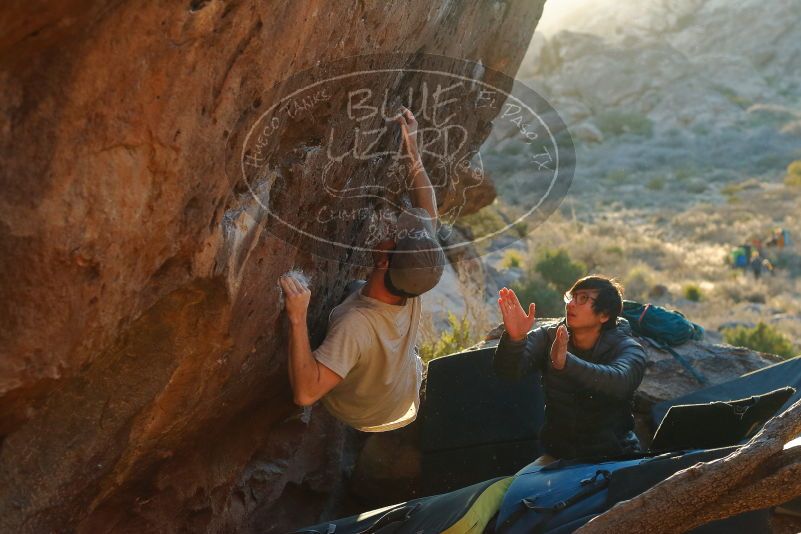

[493,319,645,458]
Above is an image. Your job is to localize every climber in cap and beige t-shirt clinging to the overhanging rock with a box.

[280,108,445,432]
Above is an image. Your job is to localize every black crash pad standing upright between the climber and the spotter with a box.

[420,347,544,493]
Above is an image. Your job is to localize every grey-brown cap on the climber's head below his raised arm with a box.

[384,208,445,297]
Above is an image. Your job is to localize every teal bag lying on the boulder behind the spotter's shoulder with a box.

[622,300,704,346]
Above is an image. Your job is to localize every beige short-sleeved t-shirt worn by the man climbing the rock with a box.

[314,290,423,432]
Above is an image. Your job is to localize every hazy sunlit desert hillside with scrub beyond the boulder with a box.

[432,0,801,360]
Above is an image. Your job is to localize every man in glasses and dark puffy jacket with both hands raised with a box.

[494,276,646,465]
